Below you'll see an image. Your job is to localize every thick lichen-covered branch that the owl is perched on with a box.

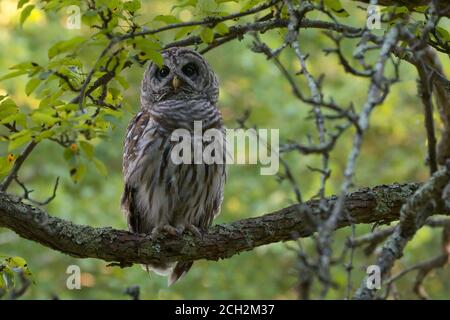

[0,183,448,267]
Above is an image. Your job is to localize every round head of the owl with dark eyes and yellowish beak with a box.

[141,48,219,106]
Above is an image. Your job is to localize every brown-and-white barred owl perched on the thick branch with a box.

[121,48,226,285]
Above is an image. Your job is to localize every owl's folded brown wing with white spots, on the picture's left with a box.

[121,112,151,233]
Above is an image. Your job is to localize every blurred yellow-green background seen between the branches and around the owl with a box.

[0,0,450,299]
